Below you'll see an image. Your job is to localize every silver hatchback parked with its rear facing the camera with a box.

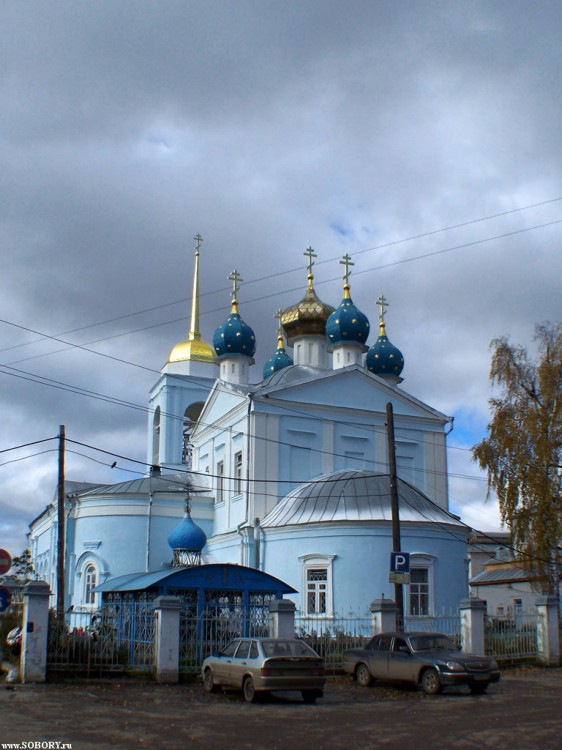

[201,638,326,703]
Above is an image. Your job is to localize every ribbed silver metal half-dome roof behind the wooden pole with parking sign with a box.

[262,470,463,528]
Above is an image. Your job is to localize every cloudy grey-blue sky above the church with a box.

[0,0,562,554]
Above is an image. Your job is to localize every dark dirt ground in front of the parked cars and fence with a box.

[0,668,562,750]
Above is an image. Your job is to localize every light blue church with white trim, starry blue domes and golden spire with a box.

[30,237,468,618]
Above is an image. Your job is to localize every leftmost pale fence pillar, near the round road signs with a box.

[20,581,51,682]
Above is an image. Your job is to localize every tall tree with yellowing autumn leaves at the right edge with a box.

[473,323,562,594]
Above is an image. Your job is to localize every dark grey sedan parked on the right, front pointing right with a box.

[344,632,500,695]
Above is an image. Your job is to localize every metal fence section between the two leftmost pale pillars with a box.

[47,601,154,676]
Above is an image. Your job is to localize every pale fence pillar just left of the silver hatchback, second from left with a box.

[154,596,180,682]
